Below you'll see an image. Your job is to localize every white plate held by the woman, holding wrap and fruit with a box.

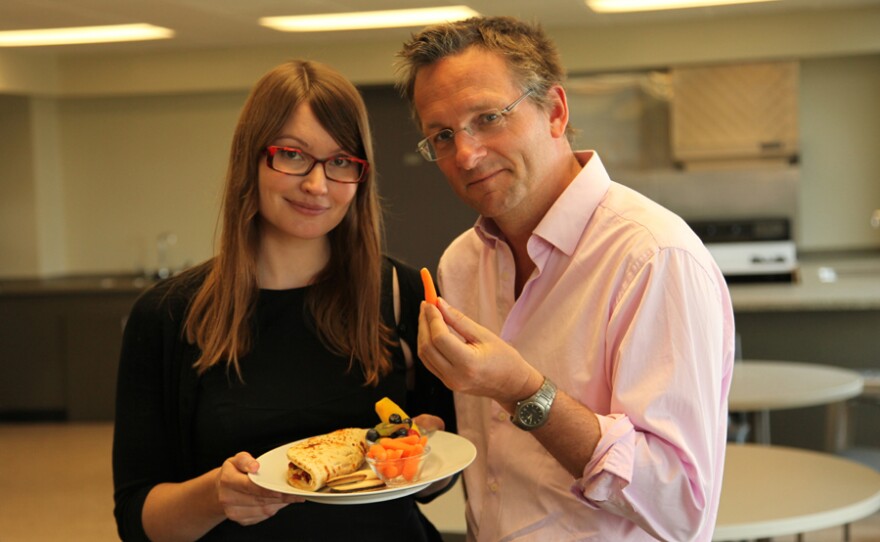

[248,431,477,504]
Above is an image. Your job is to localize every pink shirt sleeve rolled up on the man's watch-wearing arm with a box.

[572,249,733,541]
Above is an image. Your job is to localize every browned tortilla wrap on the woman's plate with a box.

[287,427,367,491]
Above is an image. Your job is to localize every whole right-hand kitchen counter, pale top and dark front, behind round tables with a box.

[730,252,880,450]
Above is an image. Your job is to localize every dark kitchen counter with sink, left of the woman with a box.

[0,274,152,421]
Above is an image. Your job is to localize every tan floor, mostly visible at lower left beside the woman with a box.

[0,423,880,542]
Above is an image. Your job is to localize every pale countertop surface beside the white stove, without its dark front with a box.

[730,253,880,313]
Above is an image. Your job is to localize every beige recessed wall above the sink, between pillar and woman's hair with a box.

[59,92,245,273]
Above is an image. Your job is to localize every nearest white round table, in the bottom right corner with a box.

[712,444,880,542]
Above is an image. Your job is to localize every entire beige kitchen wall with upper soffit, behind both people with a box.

[0,3,880,277]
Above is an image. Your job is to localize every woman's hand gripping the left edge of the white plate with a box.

[216,452,305,525]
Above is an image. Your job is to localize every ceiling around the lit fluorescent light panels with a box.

[0,0,880,54]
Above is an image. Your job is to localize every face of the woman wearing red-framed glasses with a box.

[259,103,358,244]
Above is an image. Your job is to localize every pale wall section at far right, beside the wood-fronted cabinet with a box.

[799,54,880,250]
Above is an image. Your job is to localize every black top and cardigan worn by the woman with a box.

[113,260,455,542]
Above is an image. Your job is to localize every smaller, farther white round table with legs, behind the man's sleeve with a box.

[728,360,865,444]
